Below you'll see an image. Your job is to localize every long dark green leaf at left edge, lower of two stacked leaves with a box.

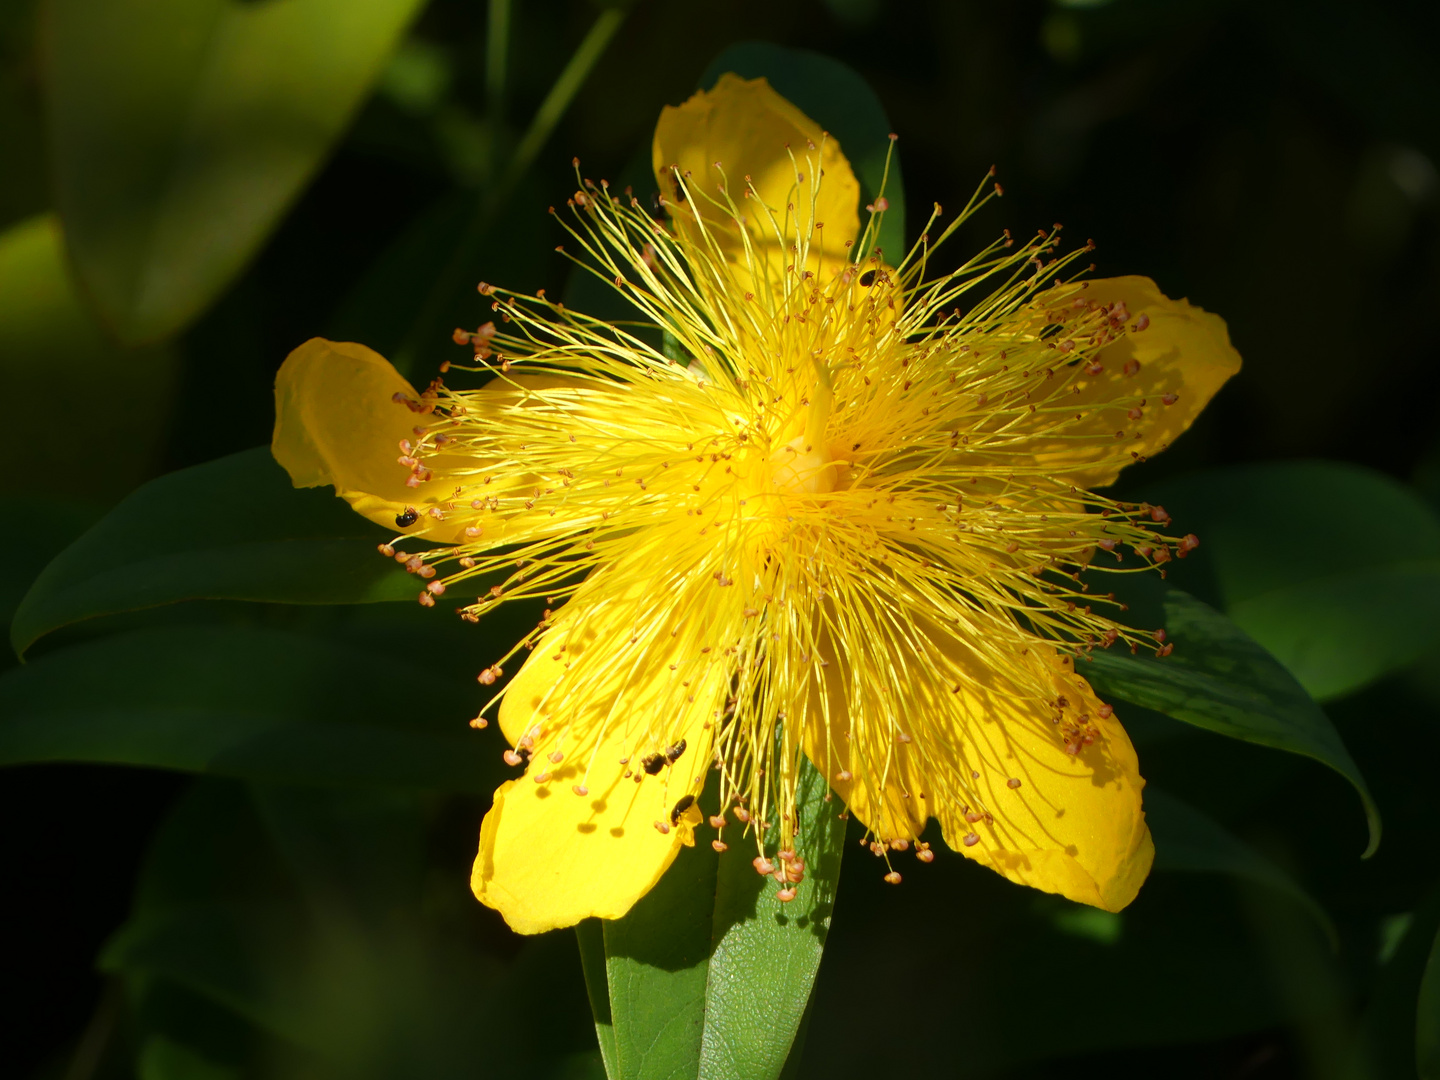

[0,626,498,792]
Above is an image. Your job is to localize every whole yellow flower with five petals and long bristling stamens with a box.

[274,76,1240,933]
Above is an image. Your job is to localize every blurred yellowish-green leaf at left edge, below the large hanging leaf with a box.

[0,213,177,500]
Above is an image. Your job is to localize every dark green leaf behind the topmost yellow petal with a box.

[700,42,906,264]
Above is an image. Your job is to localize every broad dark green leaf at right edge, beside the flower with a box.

[1146,461,1440,700]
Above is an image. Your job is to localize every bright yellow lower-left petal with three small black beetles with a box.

[471,575,729,933]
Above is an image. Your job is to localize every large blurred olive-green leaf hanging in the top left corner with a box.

[42,0,420,344]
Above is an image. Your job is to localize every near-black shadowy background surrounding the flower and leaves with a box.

[0,0,1440,1080]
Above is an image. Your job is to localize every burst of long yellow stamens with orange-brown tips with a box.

[368,135,1198,900]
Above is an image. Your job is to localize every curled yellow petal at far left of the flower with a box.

[271,337,461,541]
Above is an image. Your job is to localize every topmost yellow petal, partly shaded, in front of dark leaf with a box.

[652,72,860,258]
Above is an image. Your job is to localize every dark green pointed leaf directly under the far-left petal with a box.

[10,446,419,654]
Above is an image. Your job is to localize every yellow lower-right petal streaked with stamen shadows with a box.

[805,616,1155,912]
